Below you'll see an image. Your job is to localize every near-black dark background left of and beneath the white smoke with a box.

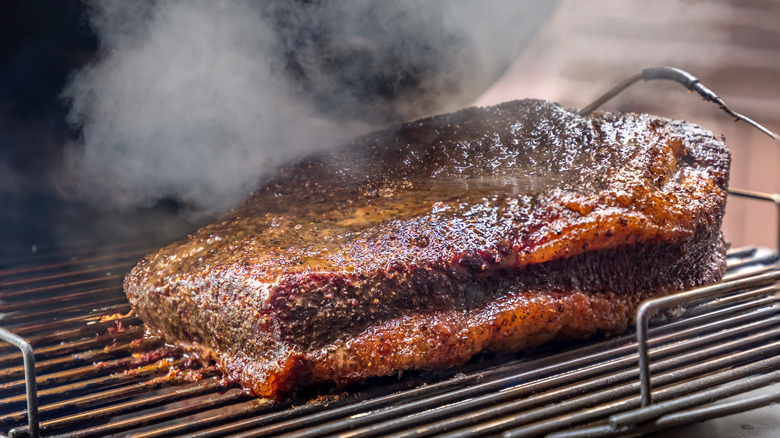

[0,0,197,261]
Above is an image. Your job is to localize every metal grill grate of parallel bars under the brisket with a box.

[0,192,780,437]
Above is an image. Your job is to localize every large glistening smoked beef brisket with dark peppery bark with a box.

[125,100,730,396]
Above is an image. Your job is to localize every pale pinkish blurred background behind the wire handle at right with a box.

[477,0,780,255]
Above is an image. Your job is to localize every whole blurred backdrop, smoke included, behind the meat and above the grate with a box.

[0,0,780,253]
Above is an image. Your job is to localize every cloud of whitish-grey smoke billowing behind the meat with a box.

[62,0,550,216]
